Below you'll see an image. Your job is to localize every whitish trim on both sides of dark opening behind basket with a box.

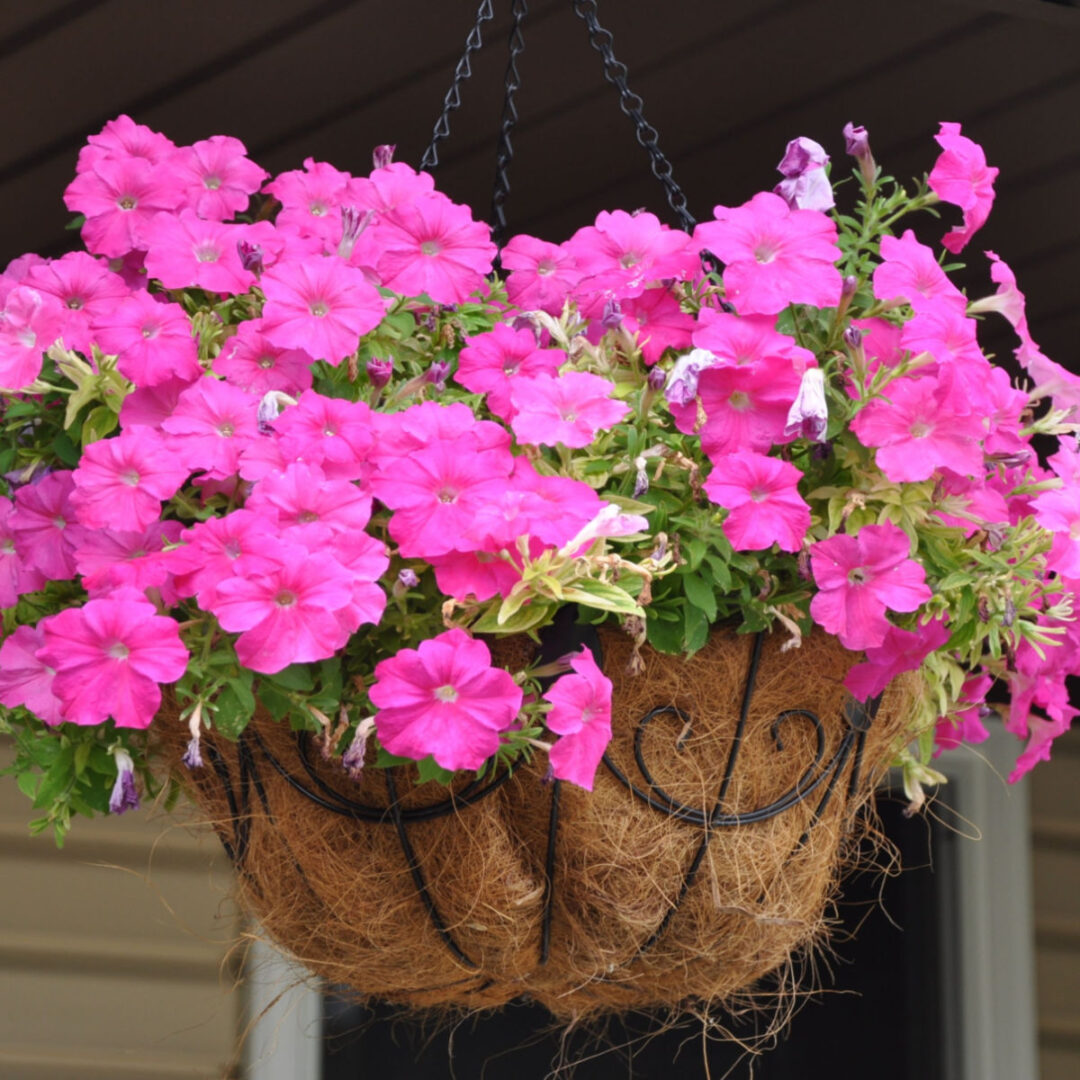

[244,721,1038,1080]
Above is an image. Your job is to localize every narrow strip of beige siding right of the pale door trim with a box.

[1030,730,1080,1080]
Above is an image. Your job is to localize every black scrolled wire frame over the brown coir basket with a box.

[198,627,880,990]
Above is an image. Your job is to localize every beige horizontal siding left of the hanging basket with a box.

[0,751,240,1080]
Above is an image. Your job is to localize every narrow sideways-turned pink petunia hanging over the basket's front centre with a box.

[543,648,611,792]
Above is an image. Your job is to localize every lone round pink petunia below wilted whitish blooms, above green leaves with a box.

[704,450,810,552]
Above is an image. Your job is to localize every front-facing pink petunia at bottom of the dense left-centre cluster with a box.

[211,546,359,675]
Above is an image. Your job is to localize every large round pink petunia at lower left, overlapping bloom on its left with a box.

[37,590,188,728]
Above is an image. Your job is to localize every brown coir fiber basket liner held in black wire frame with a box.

[159,632,910,1018]
